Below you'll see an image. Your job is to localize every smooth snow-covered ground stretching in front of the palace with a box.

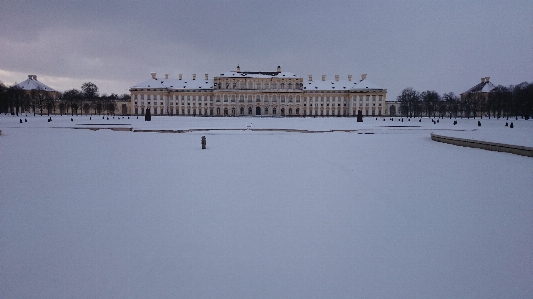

[0,115,533,298]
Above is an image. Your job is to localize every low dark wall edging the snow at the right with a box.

[431,133,533,157]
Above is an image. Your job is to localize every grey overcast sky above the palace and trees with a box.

[0,0,533,100]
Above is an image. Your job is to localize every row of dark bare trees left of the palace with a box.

[0,81,130,116]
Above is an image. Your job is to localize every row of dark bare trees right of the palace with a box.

[396,82,533,119]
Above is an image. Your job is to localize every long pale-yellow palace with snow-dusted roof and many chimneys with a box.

[129,66,387,116]
